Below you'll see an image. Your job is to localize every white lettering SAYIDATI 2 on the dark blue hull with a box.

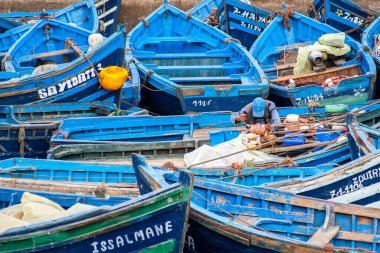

[38,63,103,99]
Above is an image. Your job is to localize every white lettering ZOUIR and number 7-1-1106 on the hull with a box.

[330,168,380,198]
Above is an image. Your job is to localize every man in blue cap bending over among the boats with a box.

[231,97,281,125]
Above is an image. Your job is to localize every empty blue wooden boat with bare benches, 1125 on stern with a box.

[127,0,269,115]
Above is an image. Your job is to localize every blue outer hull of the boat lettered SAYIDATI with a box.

[0,24,139,109]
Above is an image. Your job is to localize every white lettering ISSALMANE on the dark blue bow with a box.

[91,220,173,253]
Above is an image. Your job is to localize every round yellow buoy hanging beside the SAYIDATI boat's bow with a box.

[99,66,128,91]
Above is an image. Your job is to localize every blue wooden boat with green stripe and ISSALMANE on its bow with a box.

[0,170,193,252]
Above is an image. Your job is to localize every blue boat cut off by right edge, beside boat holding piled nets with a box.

[361,17,380,97]
